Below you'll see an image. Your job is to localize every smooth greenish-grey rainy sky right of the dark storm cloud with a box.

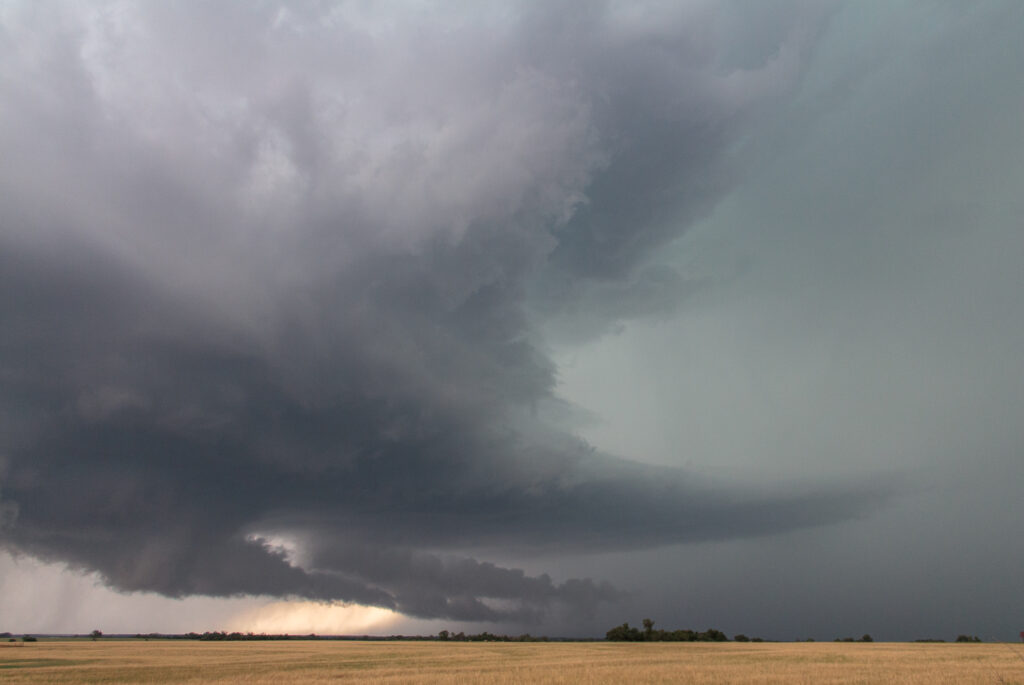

[556,3,1024,640]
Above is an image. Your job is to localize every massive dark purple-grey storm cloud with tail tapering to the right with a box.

[0,3,890,620]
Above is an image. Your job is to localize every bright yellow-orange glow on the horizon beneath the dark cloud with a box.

[228,600,404,635]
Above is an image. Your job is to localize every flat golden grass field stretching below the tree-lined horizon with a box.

[0,640,1024,685]
